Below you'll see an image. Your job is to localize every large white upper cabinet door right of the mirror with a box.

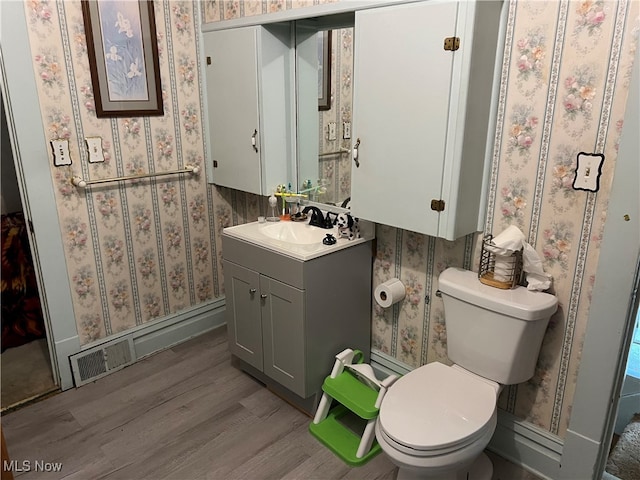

[351,2,460,236]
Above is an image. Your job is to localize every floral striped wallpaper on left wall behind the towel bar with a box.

[24,0,244,344]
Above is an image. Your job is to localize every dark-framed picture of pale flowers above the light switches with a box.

[82,0,164,118]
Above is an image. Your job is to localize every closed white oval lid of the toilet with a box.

[378,362,497,450]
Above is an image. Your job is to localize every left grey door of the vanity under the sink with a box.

[224,261,263,370]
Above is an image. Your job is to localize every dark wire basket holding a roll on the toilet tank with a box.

[478,234,522,290]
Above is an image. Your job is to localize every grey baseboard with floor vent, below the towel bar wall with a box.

[68,299,225,386]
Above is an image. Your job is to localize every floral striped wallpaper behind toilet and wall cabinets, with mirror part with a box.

[203,0,640,437]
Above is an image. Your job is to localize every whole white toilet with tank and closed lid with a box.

[375,268,558,480]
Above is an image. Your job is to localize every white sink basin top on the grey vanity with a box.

[224,221,375,260]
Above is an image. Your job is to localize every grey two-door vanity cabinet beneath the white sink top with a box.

[222,235,372,412]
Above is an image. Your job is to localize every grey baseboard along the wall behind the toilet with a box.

[371,350,563,479]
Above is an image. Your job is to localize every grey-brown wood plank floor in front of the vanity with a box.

[2,328,536,480]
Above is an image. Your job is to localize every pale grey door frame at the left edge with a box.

[0,2,80,390]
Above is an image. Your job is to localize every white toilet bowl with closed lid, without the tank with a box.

[376,362,500,480]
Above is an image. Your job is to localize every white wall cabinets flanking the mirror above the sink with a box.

[204,0,506,240]
